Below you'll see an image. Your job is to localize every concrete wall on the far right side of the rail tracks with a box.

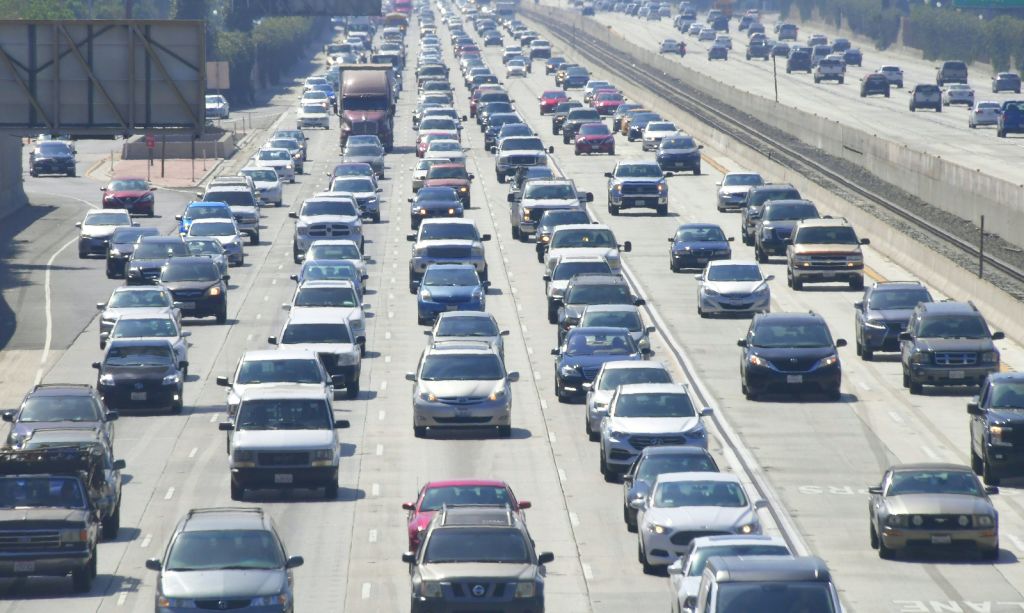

[522,7,1024,247]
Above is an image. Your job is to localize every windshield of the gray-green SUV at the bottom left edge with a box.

[164,529,285,572]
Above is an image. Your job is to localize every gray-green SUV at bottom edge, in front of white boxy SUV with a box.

[145,508,303,613]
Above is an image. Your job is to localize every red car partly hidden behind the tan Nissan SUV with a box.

[401,479,530,552]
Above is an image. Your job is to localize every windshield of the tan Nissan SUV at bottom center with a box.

[423,528,529,564]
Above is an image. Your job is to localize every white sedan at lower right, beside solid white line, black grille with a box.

[630,473,767,574]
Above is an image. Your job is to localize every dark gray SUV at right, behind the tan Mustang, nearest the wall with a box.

[899,301,1004,394]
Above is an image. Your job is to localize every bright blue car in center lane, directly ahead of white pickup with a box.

[416,264,490,325]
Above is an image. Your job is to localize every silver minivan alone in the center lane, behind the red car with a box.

[406,341,519,437]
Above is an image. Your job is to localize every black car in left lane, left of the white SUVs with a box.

[92,339,188,413]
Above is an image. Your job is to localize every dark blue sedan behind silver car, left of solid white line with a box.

[551,326,650,402]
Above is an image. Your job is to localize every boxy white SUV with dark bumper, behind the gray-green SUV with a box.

[220,386,348,500]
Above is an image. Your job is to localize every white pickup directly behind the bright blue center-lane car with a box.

[406,219,490,294]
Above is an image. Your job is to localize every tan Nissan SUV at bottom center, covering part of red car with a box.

[401,506,555,613]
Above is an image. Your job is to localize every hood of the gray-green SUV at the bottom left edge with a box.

[160,570,288,599]
